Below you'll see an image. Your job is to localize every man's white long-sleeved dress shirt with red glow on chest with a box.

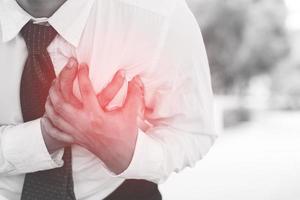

[0,0,217,200]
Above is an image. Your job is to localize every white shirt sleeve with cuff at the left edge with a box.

[0,119,63,176]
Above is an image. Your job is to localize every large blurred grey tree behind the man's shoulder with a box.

[189,0,289,94]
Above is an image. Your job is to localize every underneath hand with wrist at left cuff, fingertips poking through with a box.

[41,58,125,154]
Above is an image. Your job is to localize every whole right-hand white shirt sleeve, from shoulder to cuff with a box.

[107,1,217,183]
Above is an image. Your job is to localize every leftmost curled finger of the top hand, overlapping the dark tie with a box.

[49,81,80,124]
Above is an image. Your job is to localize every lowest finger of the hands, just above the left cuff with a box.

[41,118,74,143]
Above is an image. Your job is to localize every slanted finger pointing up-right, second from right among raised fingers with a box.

[97,70,125,108]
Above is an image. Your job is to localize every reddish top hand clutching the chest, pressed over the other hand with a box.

[46,59,144,173]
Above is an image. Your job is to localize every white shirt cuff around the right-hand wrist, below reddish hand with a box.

[105,130,164,181]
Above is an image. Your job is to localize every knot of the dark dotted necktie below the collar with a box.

[21,21,57,54]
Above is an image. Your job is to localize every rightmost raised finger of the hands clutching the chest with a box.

[123,76,144,116]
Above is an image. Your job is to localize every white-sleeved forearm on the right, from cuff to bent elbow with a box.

[109,127,216,183]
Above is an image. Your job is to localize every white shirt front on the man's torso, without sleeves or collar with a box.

[0,0,176,199]
